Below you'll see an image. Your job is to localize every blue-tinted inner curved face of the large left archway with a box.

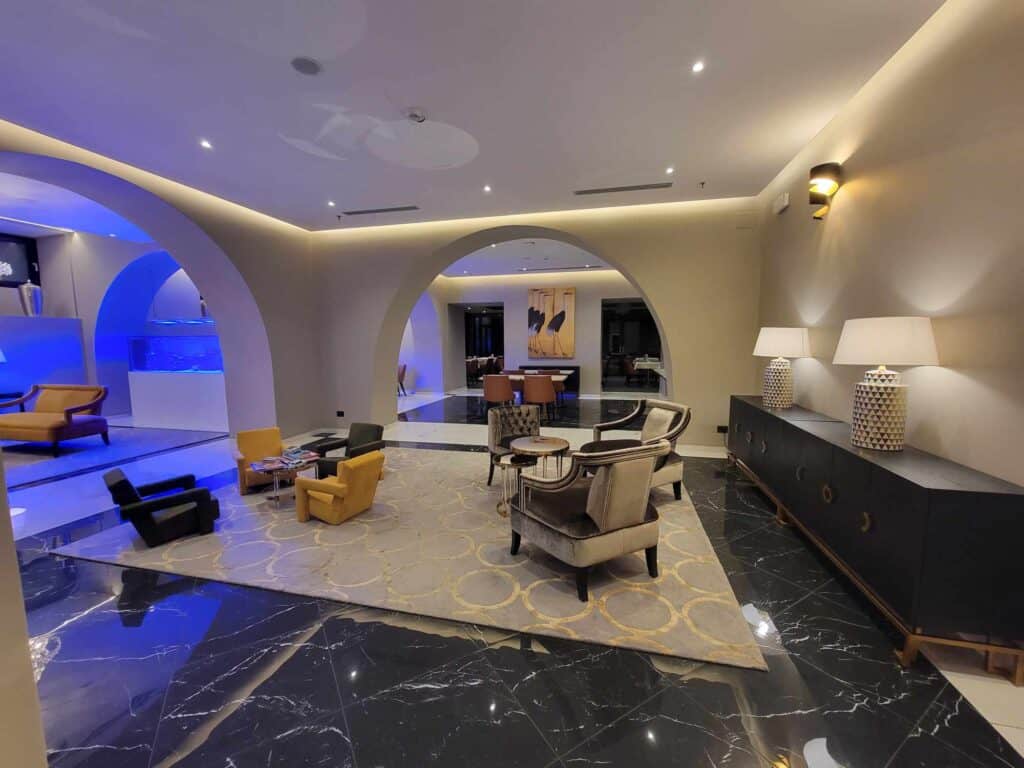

[0,152,275,432]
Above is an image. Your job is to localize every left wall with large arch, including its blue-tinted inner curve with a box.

[0,134,316,431]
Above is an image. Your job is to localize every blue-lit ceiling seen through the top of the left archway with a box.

[0,172,152,243]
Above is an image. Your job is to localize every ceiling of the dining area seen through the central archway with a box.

[441,239,612,278]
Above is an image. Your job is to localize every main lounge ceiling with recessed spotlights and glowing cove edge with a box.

[0,0,941,229]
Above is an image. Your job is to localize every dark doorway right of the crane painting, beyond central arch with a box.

[601,299,662,392]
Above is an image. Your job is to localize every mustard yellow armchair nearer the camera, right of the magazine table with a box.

[295,451,384,525]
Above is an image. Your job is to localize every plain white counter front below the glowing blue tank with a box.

[128,371,227,432]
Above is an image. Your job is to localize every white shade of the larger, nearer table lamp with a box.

[833,317,939,366]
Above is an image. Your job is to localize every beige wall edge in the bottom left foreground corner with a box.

[0,459,46,768]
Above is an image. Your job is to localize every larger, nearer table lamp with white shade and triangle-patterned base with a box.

[833,317,939,451]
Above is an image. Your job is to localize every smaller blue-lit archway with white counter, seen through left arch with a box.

[93,251,228,431]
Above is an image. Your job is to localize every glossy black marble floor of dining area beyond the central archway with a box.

[398,393,649,429]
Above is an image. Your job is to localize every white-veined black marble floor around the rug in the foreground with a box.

[22,459,1024,768]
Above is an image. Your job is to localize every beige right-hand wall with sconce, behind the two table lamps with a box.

[761,0,1024,482]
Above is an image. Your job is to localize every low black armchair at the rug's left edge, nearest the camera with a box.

[103,469,220,547]
